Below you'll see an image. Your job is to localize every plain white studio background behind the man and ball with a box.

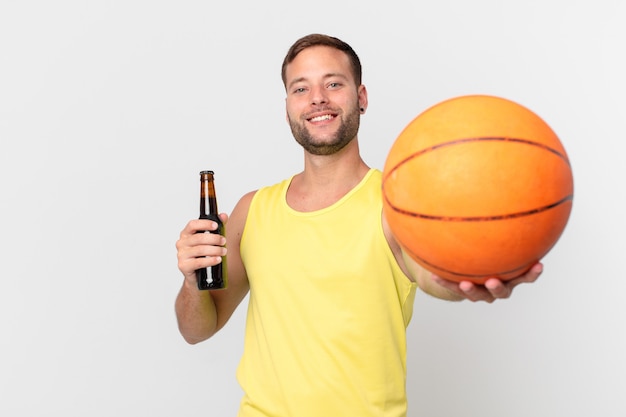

[0,0,626,417]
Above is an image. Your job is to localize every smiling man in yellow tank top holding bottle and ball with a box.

[176,35,542,417]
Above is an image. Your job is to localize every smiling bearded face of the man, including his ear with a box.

[286,46,367,155]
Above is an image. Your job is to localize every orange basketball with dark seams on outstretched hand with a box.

[382,95,574,284]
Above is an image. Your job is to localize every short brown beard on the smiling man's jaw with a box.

[287,103,361,155]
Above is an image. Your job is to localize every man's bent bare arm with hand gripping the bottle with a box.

[175,193,254,344]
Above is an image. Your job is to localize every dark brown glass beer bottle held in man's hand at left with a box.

[196,171,227,290]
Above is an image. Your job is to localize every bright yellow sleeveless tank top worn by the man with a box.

[237,170,416,417]
